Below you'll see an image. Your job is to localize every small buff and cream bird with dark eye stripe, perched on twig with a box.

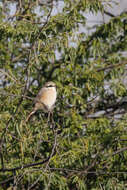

[26,81,57,122]
